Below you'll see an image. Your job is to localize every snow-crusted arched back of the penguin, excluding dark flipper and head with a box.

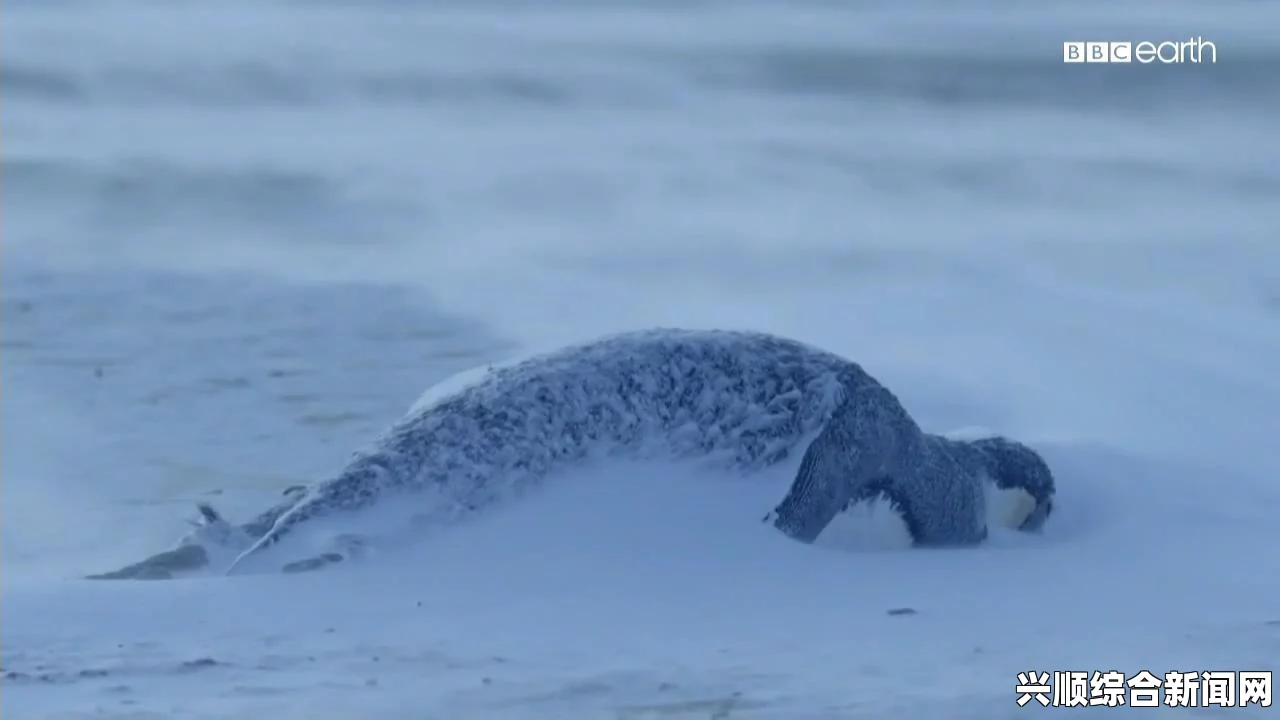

[222,329,876,571]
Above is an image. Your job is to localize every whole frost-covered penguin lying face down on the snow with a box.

[87,329,1053,577]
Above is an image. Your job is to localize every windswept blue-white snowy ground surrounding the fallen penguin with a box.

[0,0,1280,720]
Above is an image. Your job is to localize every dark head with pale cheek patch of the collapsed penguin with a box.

[969,437,1056,532]
